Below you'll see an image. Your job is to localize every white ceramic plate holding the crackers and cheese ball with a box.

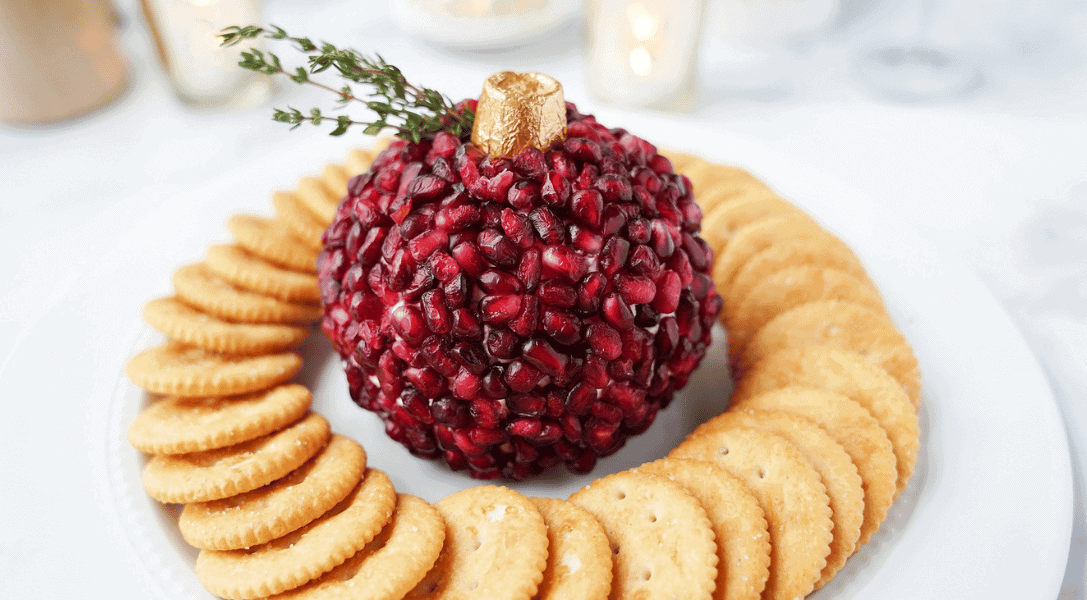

[104,119,1072,600]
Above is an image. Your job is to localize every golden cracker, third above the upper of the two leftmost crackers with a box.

[204,243,321,302]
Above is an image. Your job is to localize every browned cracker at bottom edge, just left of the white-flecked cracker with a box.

[268,493,446,600]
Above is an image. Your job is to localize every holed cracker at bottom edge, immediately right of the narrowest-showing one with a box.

[570,471,717,600]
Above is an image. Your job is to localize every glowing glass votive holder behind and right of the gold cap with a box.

[585,0,705,112]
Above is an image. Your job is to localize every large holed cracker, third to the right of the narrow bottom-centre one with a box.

[669,427,833,600]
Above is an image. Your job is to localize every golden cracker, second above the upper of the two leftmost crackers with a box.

[174,263,322,324]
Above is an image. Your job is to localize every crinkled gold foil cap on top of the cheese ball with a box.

[472,71,566,159]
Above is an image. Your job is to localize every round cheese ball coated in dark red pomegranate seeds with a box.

[318,101,722,479]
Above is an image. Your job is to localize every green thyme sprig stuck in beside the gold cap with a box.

[220,25,475,143]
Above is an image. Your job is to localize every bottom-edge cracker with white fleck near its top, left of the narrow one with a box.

[407,486,548,600]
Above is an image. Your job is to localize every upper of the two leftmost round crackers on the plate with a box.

[125,340,302,397]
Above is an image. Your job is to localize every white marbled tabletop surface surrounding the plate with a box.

[0,1,1087,599]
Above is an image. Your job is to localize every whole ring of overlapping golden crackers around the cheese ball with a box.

[126,149,921,600]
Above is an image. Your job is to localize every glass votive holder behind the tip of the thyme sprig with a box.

[140,0,272,108]
